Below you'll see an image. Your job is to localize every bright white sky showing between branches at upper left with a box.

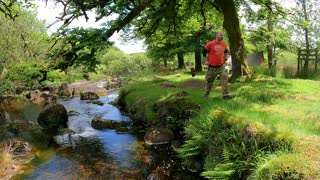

[35,1,145,54]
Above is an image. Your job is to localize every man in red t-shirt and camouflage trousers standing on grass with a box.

[202,31,234,99]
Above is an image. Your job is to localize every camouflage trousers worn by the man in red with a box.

[204,65,229,96]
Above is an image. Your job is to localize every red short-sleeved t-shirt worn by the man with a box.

[205,40,227,66]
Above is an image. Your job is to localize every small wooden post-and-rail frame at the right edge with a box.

[297,48,319,73]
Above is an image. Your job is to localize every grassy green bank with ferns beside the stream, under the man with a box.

[118,73,320,179]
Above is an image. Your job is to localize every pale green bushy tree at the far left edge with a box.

[0,6,50,94]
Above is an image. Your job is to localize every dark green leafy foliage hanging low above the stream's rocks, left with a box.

[50,28,112,72]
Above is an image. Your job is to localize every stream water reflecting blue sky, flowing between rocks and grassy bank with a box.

[14,91,199,180]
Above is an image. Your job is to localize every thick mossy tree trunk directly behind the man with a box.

[215,0,252,82]
